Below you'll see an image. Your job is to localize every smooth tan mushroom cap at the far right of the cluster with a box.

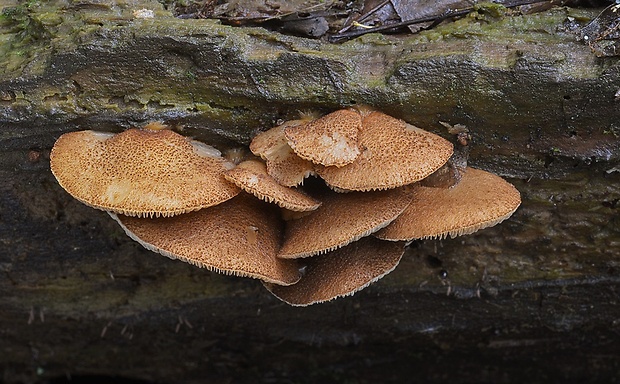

[374,167,521,240]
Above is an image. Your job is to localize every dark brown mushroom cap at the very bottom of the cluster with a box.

[263,237,405,306]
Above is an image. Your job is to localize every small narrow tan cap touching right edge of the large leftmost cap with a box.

[224,160,321,212]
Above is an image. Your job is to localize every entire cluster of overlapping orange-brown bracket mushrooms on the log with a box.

[50,107,521,306]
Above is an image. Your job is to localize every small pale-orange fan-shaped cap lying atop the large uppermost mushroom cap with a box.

[284,109,362,167]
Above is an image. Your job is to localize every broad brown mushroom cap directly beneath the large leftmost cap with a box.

[110,193,301,285]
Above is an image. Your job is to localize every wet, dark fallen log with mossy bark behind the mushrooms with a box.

[0,1,620,383]
